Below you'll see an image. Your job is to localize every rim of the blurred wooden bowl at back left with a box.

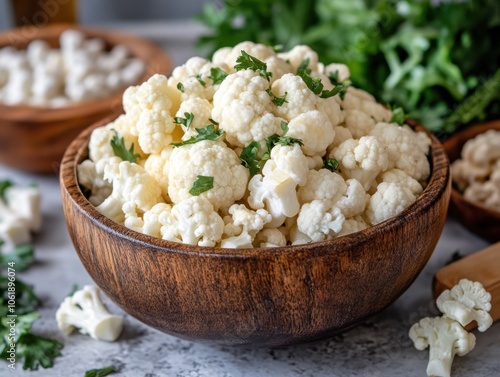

[0,24,172,122]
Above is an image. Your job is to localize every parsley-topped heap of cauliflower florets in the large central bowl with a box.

[78,42,431,248]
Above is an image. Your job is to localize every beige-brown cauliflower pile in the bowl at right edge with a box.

[451,129,500,212]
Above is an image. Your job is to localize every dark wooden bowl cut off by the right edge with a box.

[443,120,500,242]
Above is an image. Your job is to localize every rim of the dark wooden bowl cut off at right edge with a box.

[443,119,500,217]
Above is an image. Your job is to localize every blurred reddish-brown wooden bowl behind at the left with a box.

[0,25,172,173]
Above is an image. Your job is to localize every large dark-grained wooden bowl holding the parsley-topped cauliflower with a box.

[60,122,451,347]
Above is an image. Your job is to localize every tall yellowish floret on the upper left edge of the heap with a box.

[126,74,175,153]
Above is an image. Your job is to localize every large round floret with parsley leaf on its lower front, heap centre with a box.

[168,140,249,210]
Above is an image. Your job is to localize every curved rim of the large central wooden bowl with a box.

[60,118,451,258]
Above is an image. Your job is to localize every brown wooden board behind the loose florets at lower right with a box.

[433,242,500,327]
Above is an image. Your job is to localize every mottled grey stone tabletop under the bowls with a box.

[0,25,500,377]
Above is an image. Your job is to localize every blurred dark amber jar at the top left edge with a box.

[10,0,78,26]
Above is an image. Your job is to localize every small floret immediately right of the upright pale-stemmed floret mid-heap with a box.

[297,169,347,206]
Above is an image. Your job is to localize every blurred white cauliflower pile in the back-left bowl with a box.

[0,29,145,108]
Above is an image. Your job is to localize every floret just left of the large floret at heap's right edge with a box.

[330,136,389,191]
